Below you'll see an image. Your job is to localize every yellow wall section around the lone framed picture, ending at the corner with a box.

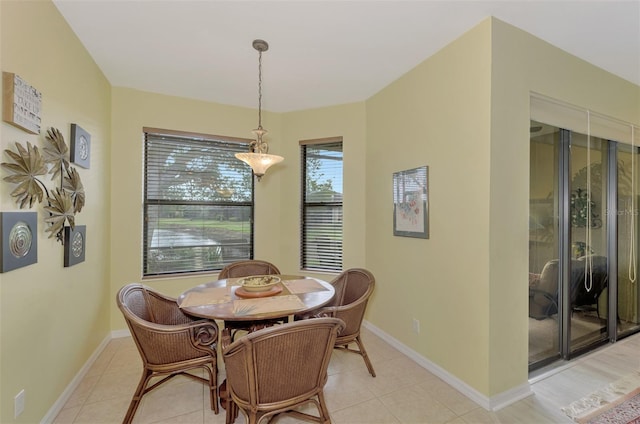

[366,16,496,393]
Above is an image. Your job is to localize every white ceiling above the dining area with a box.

[53,0,640,112]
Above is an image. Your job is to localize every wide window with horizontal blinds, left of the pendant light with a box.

[142,128,253,276]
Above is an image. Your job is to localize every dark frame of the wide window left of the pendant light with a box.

[141,127,255,279]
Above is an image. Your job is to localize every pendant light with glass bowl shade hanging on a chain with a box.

[236,40,284,181]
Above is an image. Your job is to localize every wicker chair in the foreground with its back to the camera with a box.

[222,318,344,424]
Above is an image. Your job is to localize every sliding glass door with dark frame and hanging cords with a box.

[529,121,640,369]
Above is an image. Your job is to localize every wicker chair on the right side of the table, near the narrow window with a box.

[294,268,376,377]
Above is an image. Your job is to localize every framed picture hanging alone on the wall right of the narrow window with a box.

[393,166,429,239]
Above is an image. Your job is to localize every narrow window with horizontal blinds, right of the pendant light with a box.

[300,137,342,271]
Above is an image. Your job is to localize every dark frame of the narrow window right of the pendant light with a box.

[299,137,344,272]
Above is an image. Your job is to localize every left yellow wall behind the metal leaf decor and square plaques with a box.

[0,1,112,423]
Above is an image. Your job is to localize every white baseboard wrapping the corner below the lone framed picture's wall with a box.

[362,321,533,411]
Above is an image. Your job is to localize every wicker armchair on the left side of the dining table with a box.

[116,284,218,423]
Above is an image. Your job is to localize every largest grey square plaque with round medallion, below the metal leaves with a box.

[0,212,38,272]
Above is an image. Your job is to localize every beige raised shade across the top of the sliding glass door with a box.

[530,94,640,145]
